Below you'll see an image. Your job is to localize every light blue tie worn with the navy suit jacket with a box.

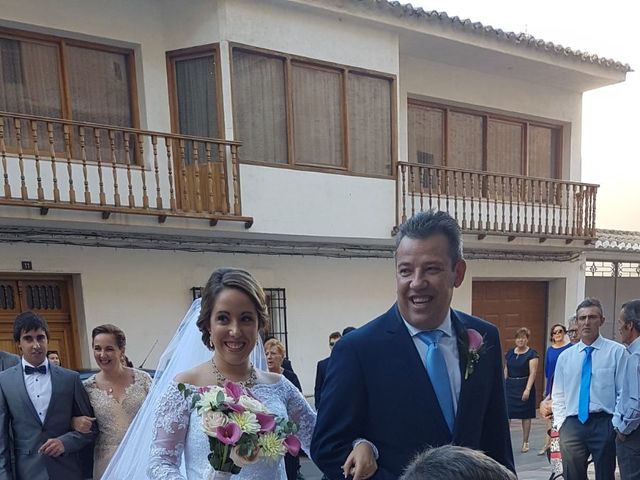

[418,330,455,432]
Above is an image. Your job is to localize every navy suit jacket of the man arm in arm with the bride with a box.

[311,305,515,480]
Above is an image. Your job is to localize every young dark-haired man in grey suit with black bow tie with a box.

[0,312,98,480]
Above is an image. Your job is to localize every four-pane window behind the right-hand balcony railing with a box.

[408,101,562,178]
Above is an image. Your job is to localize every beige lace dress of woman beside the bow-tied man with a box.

[84,369,151,479]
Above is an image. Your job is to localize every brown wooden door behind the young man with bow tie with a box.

[0,275,81,368]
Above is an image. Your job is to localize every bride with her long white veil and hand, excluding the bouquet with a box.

[102,268,377,480]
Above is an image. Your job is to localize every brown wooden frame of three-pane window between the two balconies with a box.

[229,42,398,180]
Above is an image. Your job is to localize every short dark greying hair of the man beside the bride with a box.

[396,210,463,268]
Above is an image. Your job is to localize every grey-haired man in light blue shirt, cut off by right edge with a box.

[613,300,640,480]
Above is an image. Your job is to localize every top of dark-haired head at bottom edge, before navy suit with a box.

[400,445,516,480]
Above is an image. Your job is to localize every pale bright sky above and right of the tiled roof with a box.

[402,0,640,231]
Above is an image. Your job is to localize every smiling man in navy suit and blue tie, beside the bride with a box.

[311,211,515,480]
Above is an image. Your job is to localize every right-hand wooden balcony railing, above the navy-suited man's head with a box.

[397,162,598,242]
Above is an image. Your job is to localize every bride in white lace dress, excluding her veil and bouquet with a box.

[147,268,316,480]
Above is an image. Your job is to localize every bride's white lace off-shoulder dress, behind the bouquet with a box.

[147,377,316,480]
